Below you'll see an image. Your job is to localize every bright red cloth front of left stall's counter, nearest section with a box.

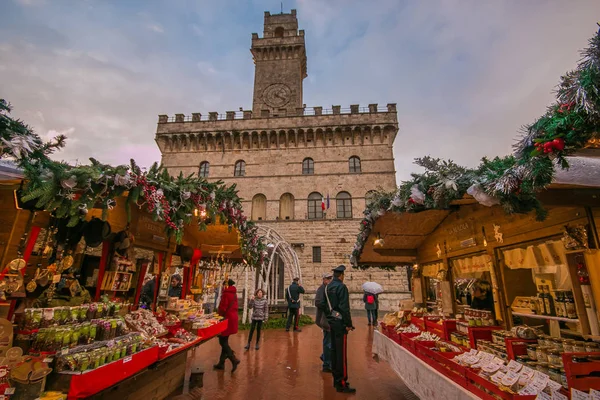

[67,346,158,400]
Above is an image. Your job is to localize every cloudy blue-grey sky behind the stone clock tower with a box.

[0,0,600,180]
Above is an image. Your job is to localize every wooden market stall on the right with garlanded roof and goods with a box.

[352,24,600,399]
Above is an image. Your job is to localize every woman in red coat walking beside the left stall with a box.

[213,279,240,372]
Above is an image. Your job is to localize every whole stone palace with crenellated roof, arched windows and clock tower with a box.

[156,10,410,309]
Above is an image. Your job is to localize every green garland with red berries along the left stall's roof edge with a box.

[20,157,267,266]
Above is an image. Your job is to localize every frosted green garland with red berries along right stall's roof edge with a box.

[351,24,600,268]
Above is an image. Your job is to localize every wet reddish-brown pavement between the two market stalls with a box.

[194,317,417,400]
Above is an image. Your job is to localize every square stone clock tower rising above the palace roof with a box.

[250,10,307,117]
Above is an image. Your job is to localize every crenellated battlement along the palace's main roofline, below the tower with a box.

[156,104,398,154]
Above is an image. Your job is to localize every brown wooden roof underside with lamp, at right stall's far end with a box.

[360,210,450,265]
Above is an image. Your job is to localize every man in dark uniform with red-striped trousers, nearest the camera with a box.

[321,265,356,393]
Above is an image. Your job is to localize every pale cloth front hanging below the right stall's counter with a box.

[373,330,479,400]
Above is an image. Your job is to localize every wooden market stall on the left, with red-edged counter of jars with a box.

[0,154,264,399]
